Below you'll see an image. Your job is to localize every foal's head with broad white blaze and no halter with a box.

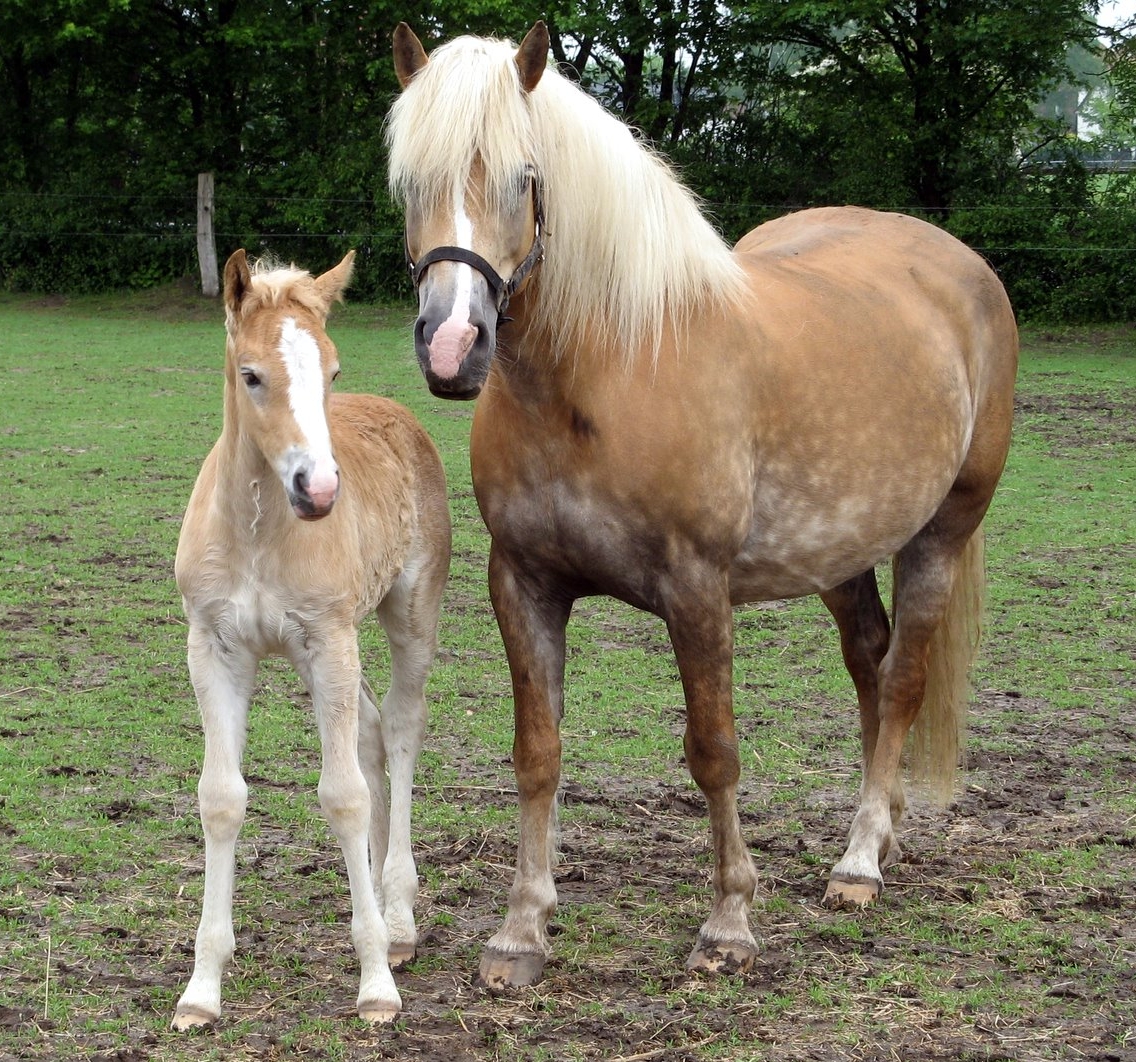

[225,250,354,520]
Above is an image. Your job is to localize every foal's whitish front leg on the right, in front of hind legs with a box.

[304,640,402,1021]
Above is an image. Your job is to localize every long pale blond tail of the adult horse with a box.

[908,525,986,804]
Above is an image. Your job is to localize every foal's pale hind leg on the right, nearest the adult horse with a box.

[371,567,443,967]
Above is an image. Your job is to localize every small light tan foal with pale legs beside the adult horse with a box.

[174,251,450,1029]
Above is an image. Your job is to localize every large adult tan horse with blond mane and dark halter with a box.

[389,23,1018,986]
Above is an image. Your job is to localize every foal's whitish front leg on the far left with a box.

[173,626,257,1029]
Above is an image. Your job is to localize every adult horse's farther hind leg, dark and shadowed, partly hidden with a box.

[820,568,907,849]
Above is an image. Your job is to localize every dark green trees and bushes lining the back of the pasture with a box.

[0,0,1136,312]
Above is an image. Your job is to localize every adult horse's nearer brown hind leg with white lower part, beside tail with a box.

[825,511,985,906]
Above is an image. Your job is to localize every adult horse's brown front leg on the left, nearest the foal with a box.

[478,546,571,989]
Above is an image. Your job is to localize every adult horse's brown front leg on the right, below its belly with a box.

[665,572,758,972]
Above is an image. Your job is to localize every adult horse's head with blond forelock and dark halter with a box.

[389,23,549,399]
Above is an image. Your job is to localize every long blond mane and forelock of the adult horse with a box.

[387,37,743,360]
